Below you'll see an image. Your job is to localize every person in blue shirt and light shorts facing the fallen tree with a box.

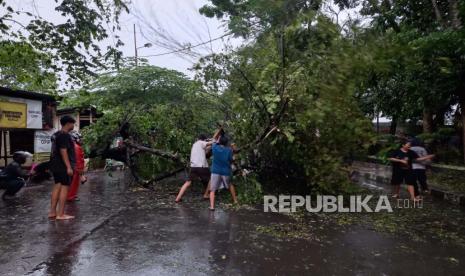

[210,135,237,211]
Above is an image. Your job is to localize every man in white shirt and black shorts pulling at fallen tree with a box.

[176,134,213,203]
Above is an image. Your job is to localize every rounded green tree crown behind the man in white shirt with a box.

[65,66,222,167]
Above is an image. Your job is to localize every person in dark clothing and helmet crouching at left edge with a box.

[1,151,30,200]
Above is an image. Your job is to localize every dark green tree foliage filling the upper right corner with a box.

[354,0,465,160]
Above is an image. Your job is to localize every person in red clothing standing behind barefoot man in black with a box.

[67,130,87,201]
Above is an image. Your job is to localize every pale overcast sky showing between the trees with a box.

[8,0,241,76]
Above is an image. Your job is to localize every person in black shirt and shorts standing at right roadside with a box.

[389,140,433,201]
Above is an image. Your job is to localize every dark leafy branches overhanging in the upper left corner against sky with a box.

[0,0,128,85]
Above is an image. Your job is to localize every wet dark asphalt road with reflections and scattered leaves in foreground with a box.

[0,169,465,275]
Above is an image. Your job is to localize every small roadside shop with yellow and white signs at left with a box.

[0,87,57,167]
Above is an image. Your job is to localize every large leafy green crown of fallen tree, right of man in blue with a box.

[196,1,372,193]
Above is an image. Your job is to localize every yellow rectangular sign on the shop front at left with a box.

[0,102,27,128]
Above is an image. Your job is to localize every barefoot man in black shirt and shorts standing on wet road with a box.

[48,116,76,220]
